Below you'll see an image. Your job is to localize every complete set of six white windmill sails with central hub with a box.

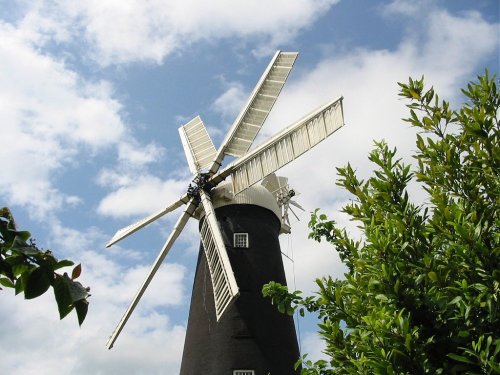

[106,51,344,348]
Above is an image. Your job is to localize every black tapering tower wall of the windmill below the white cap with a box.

[181,205,299,375]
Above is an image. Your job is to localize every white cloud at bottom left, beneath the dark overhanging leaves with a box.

[0,274,185,375]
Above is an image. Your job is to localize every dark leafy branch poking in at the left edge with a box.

[0,207,90,325]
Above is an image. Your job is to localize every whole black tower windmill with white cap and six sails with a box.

[106,51,344,375]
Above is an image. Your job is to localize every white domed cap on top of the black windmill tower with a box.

[200,181,281,221]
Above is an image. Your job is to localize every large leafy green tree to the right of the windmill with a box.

[263,71,500,374]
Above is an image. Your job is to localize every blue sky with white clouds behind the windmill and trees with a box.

[0,0,500,375]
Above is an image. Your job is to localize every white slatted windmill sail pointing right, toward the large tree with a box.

[210,97,344,194]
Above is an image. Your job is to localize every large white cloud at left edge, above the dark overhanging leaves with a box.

[0,23,125,214]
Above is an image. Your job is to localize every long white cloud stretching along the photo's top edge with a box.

[12,0,338,65]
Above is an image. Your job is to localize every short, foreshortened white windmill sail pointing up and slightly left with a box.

[179,116,217,174]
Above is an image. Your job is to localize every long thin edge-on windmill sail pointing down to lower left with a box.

[106,198,198,349]
